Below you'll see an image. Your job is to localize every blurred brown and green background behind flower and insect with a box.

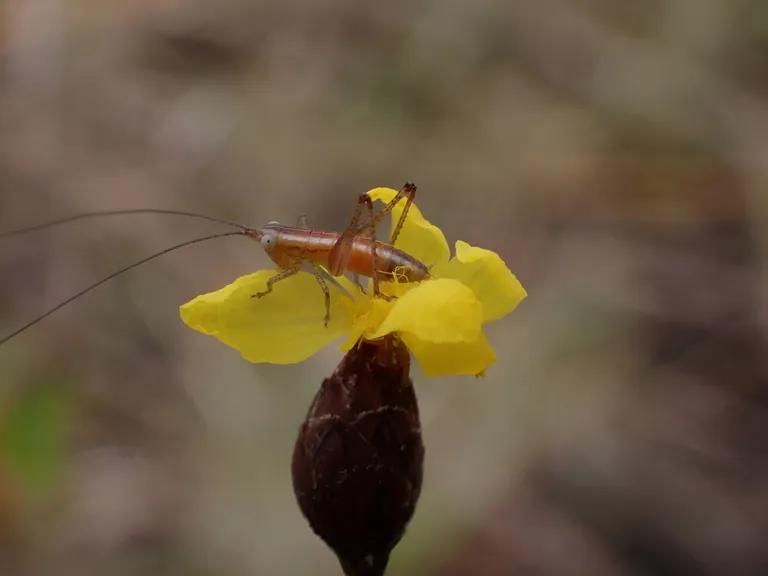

[0,0,768,576]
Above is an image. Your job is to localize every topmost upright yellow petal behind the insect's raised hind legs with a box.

[368,188,451,266]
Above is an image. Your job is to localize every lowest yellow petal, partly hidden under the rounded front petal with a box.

[402,332,496,376]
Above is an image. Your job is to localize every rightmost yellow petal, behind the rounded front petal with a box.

[432,240,527,322]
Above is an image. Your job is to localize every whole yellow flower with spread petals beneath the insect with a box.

[180,188,526,376]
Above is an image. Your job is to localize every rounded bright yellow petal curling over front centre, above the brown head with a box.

[366,279,483,342]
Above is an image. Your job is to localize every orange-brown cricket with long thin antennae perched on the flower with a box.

[0,182,429,346]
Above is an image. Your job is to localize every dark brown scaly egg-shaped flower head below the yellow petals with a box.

[292,337,424,576]
